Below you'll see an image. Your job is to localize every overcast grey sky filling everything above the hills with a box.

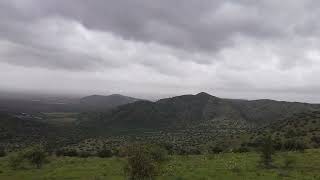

[0,0,320,102]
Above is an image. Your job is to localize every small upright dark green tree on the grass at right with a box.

[261,136,274,168]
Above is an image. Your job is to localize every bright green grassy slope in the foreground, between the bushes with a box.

[0,149,320,180]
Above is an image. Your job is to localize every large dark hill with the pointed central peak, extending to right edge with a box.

[79,92,320,130]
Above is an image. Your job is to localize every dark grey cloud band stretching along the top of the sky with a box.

[0,0,319,67]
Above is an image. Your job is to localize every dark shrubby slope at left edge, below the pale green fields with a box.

[0,112,87,150]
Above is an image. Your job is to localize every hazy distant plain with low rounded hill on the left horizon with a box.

[0,94,139,113]
